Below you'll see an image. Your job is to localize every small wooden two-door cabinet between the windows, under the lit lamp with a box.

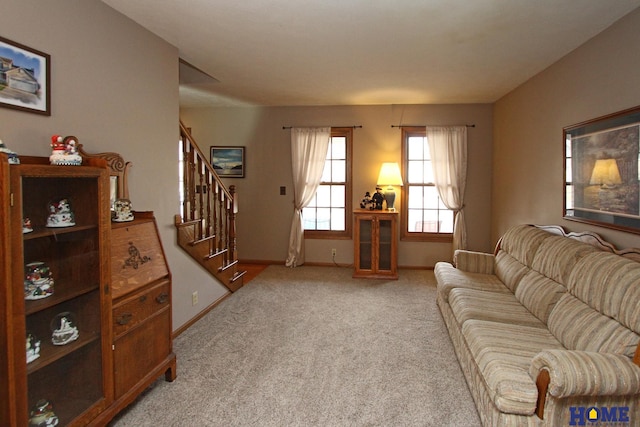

[353,210,398,279]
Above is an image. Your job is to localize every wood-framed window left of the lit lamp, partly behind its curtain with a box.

[302,128,353,238]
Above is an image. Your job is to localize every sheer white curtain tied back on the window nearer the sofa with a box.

[426,126,467,252]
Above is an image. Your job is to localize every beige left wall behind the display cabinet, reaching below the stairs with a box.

[0,0,230,328]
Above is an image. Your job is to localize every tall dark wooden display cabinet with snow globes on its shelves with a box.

[0,155,113,427]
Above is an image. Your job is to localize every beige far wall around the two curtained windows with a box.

[180,104,492,267]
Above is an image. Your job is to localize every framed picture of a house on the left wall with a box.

[0,37,51,116]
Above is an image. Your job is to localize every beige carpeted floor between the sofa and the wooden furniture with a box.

[111,266,480,427]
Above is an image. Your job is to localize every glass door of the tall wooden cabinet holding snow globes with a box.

[12,165,105,425]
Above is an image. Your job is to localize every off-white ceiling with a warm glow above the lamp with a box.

[102,0,640,106]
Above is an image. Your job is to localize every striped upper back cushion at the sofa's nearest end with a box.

[567,252,640,333]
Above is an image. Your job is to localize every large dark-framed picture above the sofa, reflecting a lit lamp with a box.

[563,106,640,234]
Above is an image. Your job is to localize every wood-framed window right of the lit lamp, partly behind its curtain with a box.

[402,127,453,241]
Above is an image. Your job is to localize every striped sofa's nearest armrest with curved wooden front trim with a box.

[529,350,640,419]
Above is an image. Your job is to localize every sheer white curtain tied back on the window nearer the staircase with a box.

[285,127,331,267]
